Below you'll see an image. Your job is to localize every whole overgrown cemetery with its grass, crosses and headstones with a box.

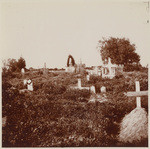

[2,53,148,147]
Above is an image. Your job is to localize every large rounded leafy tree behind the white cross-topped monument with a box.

[98,37,140,66]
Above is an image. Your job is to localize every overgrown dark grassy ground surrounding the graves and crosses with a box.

[2,72,148,147]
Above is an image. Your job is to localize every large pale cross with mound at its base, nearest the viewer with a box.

[118,81,148,143]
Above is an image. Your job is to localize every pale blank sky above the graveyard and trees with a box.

[0,0,150,68]
